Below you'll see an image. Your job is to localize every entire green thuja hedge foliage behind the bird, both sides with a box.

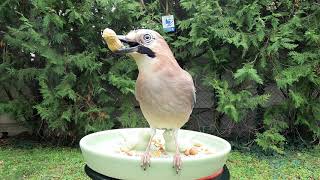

[0,0,320,153]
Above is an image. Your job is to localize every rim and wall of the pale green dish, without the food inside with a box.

[80,128,231,180]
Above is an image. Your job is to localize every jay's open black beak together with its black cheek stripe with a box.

[115,35,155,58]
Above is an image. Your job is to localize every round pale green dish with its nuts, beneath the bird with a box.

[80,128,231,180]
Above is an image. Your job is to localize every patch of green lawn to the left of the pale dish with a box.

[0,146,89,180]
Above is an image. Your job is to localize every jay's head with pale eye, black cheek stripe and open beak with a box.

[116,29,175,70]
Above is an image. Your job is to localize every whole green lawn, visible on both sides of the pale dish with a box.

[0,141,320,180]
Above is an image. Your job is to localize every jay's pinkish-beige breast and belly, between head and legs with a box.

[136,70,192,128]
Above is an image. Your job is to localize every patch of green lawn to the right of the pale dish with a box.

[227,147,320,180]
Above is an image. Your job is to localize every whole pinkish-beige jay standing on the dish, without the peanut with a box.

[102,29,196,173]
